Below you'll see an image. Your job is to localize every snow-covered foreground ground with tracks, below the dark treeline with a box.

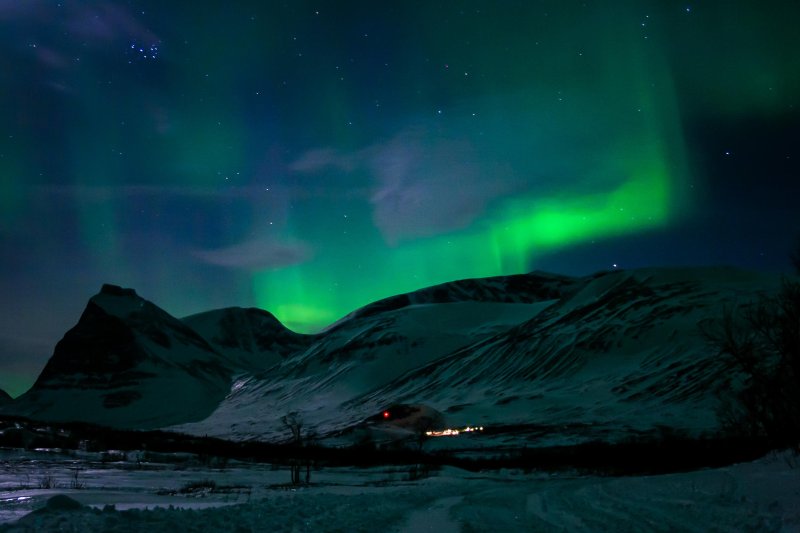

[0,455,800,533]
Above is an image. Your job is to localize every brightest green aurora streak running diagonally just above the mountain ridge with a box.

[254,155,672,332]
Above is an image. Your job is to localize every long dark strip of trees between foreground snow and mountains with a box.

[0,418,770,475]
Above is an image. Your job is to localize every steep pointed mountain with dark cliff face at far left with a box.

[4,285,245,428]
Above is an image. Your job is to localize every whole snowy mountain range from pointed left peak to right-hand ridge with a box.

[4,268,779,444]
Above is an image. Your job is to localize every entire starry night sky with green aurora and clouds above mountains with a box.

[0,0,800,395]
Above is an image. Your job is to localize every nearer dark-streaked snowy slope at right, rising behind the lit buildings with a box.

[356,270,770,443]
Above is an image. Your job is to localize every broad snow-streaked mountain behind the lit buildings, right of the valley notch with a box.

[172,269,777,444]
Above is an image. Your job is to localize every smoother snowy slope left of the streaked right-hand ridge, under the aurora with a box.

[177,302,550,440]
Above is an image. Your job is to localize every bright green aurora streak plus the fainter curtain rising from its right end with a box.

[253,17,692,332]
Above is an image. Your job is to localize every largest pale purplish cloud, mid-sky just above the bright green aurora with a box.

[289,128,516,245]
